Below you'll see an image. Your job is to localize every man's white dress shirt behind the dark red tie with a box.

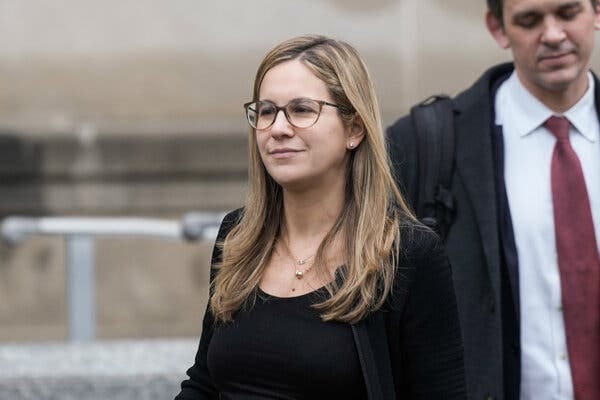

[495,72,600,400]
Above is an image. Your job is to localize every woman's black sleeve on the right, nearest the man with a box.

[401,227,467,400]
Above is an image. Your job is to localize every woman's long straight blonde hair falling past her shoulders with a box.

[210,35,413,323]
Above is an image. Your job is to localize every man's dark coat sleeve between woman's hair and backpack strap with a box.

[386,115,419,208]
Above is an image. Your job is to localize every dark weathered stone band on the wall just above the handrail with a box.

[0,130,248,217]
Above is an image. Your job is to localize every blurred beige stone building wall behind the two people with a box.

[0,0,598,341]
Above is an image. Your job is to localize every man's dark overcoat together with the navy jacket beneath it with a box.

[387,63,600,399]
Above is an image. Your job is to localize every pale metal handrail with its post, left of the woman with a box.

[0,212,225,341]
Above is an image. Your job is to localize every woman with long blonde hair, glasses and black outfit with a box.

[176,36,466,400]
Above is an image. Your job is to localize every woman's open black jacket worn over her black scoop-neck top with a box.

[175,210,466,400]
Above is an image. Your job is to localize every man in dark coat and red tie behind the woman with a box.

[388,0,600,400]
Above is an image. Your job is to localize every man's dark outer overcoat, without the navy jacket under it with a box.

[387,64,513,399]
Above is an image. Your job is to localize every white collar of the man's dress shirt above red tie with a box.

[506,72,600,142]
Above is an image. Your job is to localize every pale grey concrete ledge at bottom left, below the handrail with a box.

[0,338,198,400]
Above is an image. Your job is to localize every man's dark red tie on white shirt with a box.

[544,117,600,400]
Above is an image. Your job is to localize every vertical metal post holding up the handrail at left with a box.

[66,235,96,342]
